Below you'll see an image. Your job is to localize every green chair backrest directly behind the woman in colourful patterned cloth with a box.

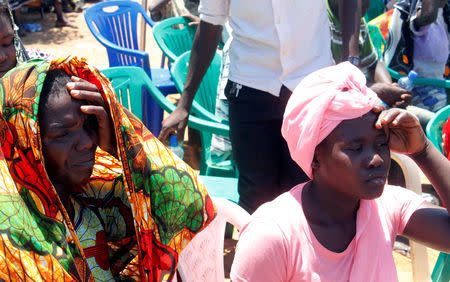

[102,67,147,120]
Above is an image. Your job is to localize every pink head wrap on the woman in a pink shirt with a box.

[281,62,379,179]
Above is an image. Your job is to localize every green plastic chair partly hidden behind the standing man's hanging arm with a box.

[170,51,237,177]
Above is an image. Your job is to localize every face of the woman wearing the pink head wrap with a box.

[314,112,390,199]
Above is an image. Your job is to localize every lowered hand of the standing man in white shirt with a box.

[158,106,189,142]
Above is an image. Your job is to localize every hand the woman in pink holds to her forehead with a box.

[375,108,427,155]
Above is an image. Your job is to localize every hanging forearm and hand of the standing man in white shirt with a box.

[159,21,222,140]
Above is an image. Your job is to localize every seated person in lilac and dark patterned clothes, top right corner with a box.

[383,0,450,112]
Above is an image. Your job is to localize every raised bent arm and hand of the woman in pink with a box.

[376,109,450,253]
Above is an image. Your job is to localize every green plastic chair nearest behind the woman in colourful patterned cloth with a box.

[102,66,239,203]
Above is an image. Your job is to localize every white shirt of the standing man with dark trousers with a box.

[199,0,333,96]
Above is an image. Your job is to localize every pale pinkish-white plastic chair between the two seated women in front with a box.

[178,197,250,282]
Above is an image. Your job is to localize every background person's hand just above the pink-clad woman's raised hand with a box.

[370,83,412,108]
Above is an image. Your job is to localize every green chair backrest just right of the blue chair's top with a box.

[153,17,197,62]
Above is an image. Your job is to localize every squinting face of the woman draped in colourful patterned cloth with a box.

[40,85,98,187]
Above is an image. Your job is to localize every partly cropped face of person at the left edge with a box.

[0,15,16,78]
